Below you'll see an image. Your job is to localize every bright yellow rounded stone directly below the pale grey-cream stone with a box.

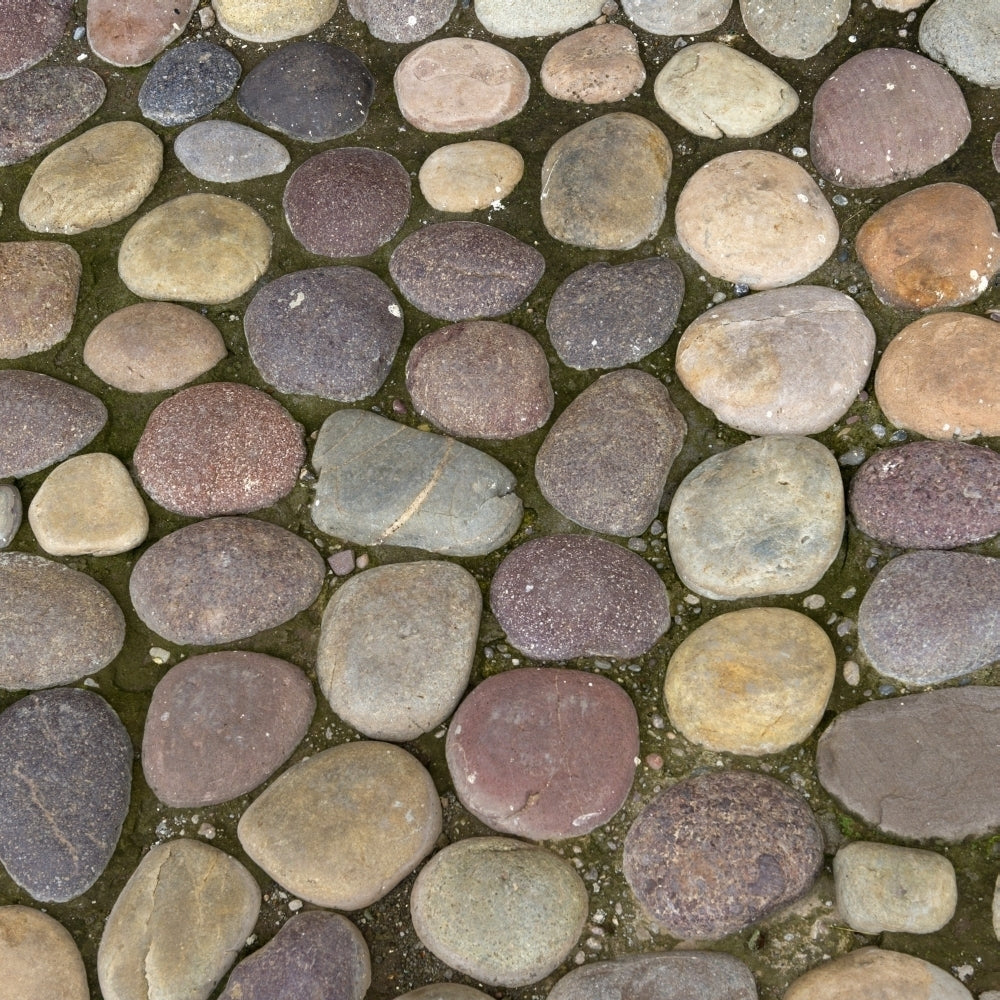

[663,608,837,757]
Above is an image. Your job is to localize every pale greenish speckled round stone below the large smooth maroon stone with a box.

[410,837,588,987]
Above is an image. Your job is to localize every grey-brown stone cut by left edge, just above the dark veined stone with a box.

[0,552,125,691]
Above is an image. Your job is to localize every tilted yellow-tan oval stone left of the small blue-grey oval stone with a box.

[18,121,163,235]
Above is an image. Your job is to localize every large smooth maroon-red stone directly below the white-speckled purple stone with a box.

[445,667,639,840]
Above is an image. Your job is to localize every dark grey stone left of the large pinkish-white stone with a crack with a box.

[545,257,684,371]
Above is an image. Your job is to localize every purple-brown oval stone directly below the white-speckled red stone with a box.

[129,517,326,646]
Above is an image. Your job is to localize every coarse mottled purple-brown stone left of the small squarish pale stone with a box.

[623,771,823,940]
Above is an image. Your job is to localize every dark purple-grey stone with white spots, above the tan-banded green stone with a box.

[243,267,403,403]
